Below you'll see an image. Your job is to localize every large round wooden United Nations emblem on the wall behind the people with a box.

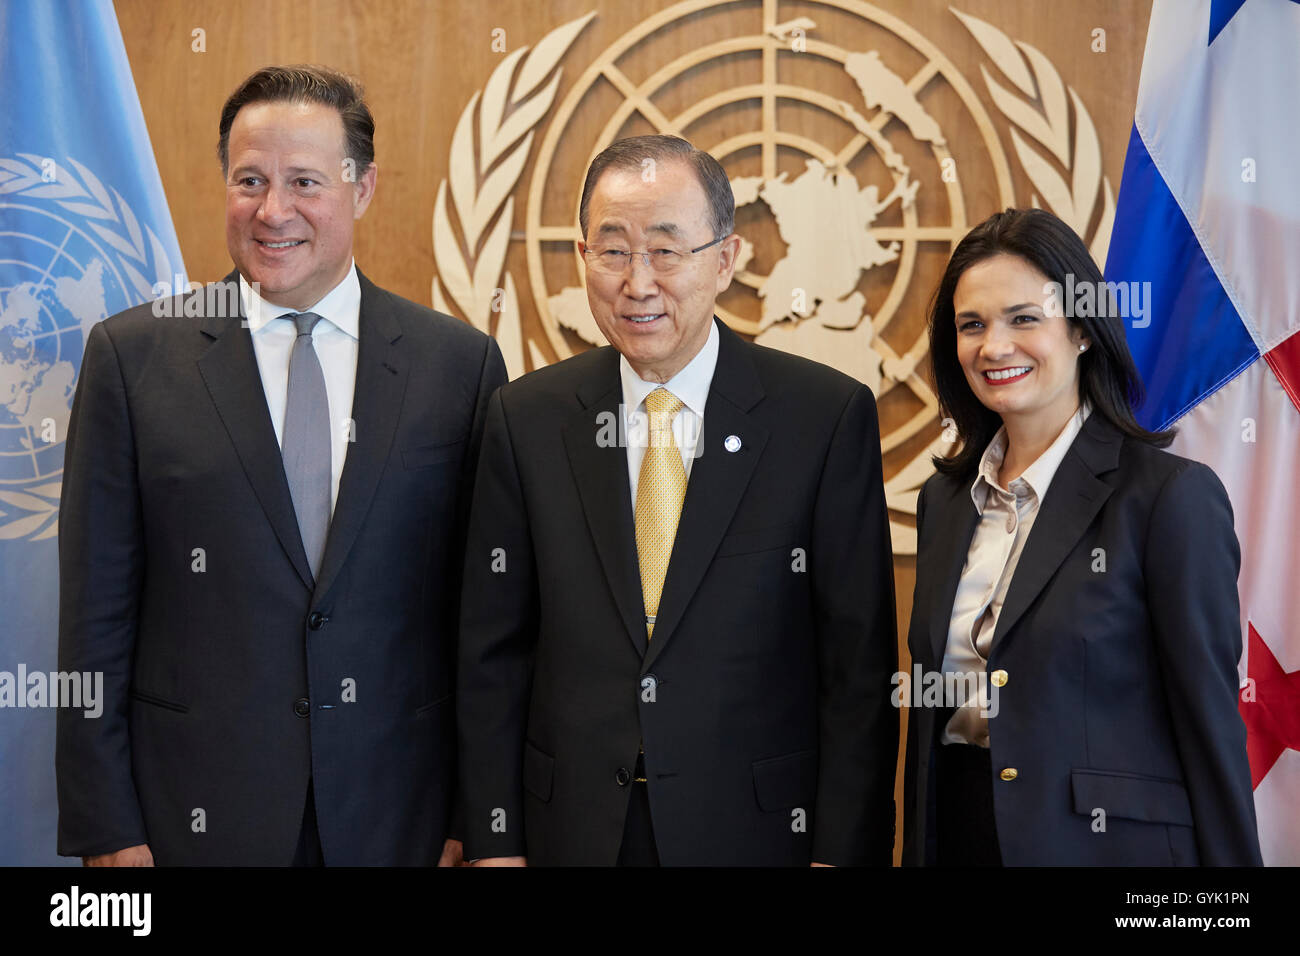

[433,0,1114,554]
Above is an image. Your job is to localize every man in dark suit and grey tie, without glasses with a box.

[57,68,504,865]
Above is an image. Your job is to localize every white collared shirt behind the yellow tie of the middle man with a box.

[619,319,719,511]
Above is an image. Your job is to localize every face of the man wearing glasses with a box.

[579,161,740,382]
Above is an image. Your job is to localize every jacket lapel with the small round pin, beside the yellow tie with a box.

[638,319,768,667]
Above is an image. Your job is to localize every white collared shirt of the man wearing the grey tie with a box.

[239,261,361,512]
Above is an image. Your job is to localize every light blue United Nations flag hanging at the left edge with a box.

[0,0,185,865]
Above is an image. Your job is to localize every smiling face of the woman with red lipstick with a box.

[953,255,1089,431]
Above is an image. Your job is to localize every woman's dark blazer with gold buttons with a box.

[904,411,1260,866]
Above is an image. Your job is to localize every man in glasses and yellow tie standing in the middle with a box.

[458,137,898,866]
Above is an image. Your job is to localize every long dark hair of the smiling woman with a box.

[930,209,1174,476]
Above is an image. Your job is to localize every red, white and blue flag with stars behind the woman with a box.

[1106,0,1300,866]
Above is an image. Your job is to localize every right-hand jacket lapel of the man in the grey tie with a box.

[316,269,408,600]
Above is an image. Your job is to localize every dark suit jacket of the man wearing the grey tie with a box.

[56,273,506,865]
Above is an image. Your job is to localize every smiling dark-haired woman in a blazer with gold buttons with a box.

[904,209,1260,866]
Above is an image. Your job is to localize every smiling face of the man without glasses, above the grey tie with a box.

[226,103,376,310]
